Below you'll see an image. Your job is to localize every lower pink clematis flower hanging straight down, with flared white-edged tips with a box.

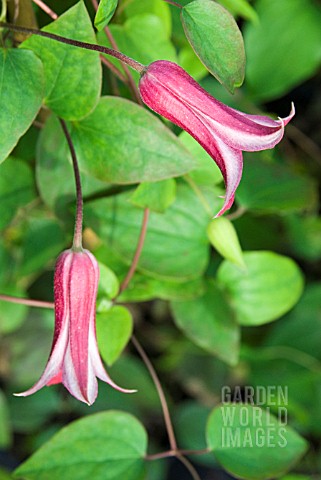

[16,250,135,405]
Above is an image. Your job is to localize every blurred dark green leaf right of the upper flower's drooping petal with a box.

[236,154,318,215]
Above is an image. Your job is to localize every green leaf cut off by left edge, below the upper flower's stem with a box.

[0,48,43,163]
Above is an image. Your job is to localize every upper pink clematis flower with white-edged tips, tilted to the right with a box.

[139,60,295,217]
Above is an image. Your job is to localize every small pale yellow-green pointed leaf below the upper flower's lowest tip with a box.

[207,217,245,268]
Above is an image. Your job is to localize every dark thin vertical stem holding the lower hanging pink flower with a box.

[59,118,83,252]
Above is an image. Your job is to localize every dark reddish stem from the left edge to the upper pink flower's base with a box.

[0,22,145,73]
